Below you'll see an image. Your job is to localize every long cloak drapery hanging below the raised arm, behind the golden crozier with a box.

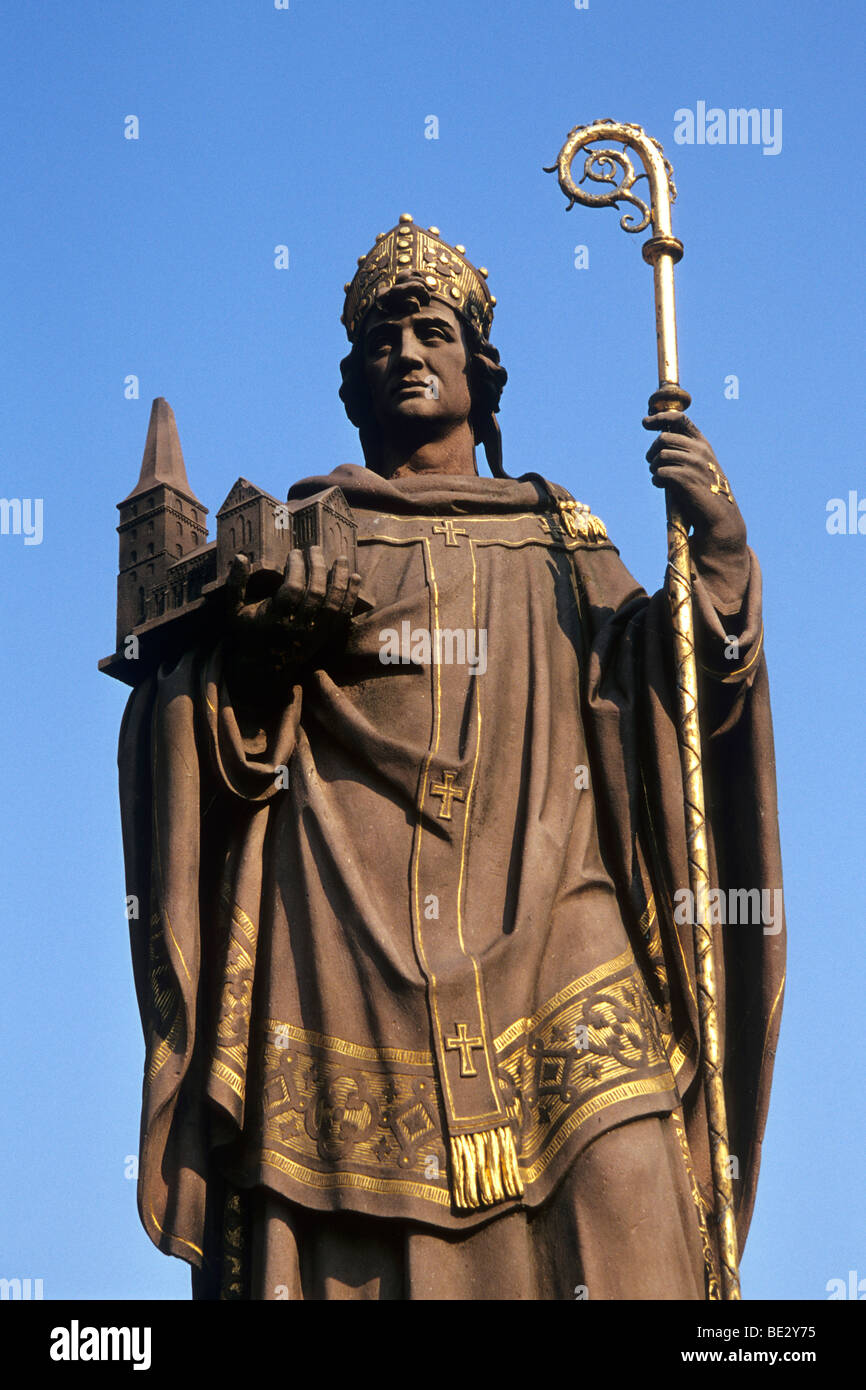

[575,546,785,1247]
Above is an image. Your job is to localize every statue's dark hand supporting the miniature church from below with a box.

[227,545,361,670]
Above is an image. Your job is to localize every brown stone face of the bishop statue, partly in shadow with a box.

[364,300,473,434]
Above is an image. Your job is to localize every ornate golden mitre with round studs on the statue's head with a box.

[341,213,496,342]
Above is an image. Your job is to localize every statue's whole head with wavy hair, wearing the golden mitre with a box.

[339,213,507,477]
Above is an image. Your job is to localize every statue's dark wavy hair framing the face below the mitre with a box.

[339,272,509,478]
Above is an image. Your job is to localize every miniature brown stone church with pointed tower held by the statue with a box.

[99,396,356,685]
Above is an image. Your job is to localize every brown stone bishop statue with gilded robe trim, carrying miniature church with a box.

[101,205,784,1300]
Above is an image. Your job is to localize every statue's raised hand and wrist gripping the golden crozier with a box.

[642,410,749,609]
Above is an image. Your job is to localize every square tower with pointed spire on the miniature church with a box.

[117,396,207,652]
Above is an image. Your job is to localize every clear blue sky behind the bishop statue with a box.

[0,0,866,1298]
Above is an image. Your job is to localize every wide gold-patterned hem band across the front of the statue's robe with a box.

[247,951,681,1207]
